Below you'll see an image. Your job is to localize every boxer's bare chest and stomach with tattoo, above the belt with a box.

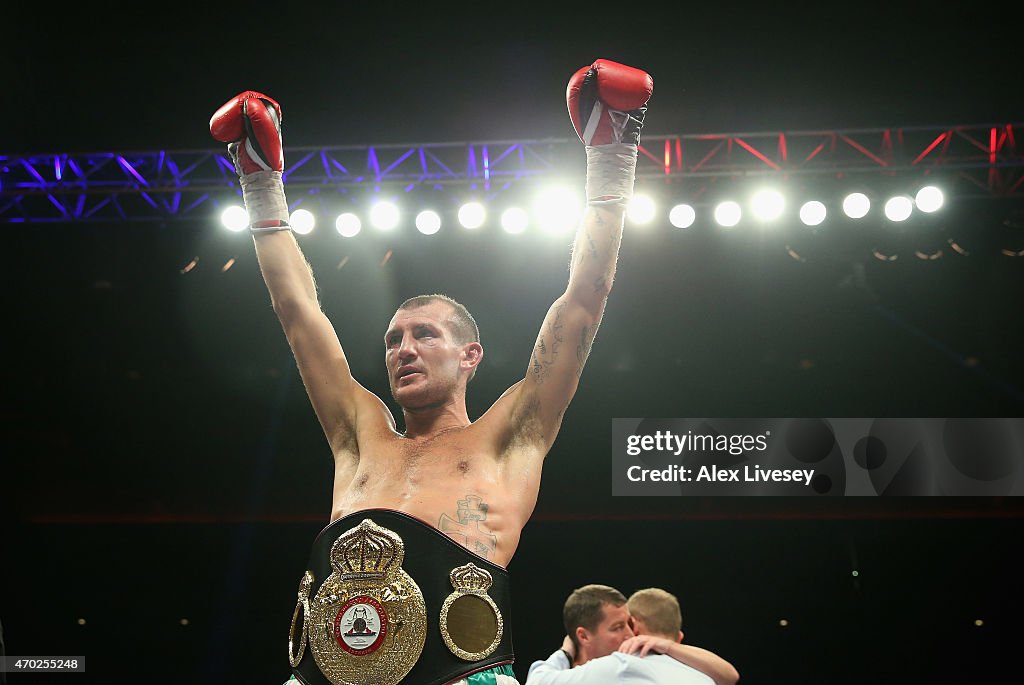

[331,401,544,566]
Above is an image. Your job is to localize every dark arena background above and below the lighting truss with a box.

[0,3,1024,684]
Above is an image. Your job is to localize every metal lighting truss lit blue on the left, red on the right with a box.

[0,122,1024,223]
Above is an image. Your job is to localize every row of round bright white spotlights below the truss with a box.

[221,185,944,238]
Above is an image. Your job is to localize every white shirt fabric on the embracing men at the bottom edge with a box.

[526,649,715,685]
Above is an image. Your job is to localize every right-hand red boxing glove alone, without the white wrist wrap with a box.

[565,59,654,145]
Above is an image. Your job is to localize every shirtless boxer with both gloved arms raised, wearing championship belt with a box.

[210,59,653,685]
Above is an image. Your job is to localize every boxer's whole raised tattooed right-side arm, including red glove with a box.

[503,59,653,452]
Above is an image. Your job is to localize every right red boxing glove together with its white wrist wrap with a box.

[565,59,654,205]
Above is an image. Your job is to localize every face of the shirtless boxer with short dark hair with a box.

[384,302,465,410]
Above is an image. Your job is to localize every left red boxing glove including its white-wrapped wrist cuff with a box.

[210,90,290,232]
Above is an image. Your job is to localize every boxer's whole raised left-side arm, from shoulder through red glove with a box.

[210,91,372,454]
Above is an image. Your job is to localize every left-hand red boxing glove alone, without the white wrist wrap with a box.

[210,90,285,176]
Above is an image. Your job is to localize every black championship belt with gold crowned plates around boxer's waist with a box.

[288,509,514,685]
